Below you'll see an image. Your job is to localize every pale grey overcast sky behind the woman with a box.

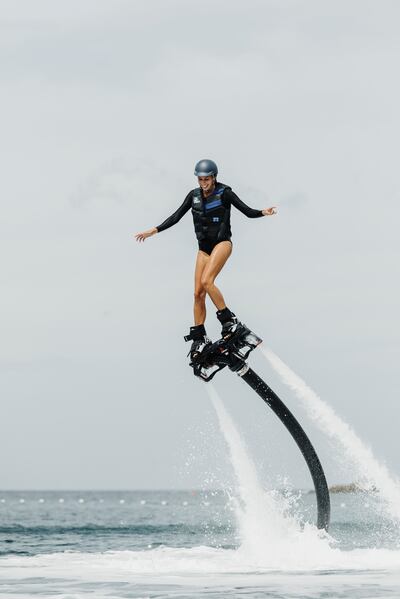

[0,0,400,489]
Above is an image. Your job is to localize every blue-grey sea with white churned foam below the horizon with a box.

[0,490,400,599]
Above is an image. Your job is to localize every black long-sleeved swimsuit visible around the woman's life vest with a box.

[157,183,263,254]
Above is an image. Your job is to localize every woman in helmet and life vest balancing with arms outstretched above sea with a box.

[135,160,276,360]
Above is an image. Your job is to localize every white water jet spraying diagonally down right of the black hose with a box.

[261,347,400,519]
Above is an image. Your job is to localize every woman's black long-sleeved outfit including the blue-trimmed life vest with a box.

[157,183,263,254]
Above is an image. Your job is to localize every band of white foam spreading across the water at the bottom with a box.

[0,539,400,581]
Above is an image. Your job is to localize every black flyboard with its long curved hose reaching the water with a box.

[185,323,331,530]
